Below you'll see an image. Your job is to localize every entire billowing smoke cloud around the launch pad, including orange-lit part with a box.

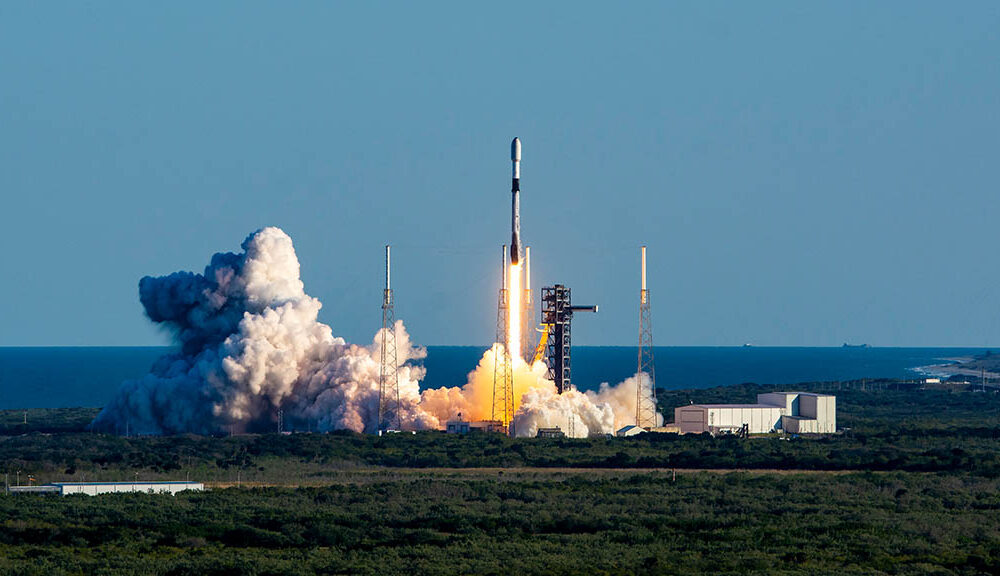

[94,228,662,437]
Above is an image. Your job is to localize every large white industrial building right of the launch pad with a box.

[674,392,837,434]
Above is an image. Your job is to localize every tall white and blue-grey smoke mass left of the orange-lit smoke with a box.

[94,228,436,434]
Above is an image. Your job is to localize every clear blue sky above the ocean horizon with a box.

[0,1,1000,346]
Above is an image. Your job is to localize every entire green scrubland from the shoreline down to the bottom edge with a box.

[0,381,1000,574]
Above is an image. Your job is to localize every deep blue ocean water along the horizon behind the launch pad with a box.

[0,346,986,409]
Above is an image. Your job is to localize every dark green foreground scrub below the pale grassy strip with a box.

[0,471,1000,575]
